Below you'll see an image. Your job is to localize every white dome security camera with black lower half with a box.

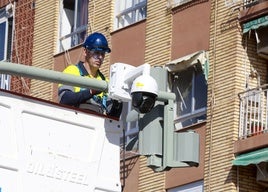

[131,75,158,113]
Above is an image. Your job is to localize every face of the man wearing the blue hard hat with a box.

[85,49,105,68]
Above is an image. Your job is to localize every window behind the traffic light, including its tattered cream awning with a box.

[166,51,208,129]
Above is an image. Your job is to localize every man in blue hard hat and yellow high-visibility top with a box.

[58,32,122,117]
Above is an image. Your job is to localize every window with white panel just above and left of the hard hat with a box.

[59,0,88,52]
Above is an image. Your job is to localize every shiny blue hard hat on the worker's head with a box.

[83,32,111,53]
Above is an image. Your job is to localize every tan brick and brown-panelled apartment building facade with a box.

[0,0,268,192]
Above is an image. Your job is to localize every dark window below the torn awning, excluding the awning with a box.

[172,65,207,128]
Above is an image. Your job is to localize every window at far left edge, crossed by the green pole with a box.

[0,8,13,90]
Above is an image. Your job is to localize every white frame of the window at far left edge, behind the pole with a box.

[0,8,13,90]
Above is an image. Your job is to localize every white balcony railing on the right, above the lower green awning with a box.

[239,85,268,139]
